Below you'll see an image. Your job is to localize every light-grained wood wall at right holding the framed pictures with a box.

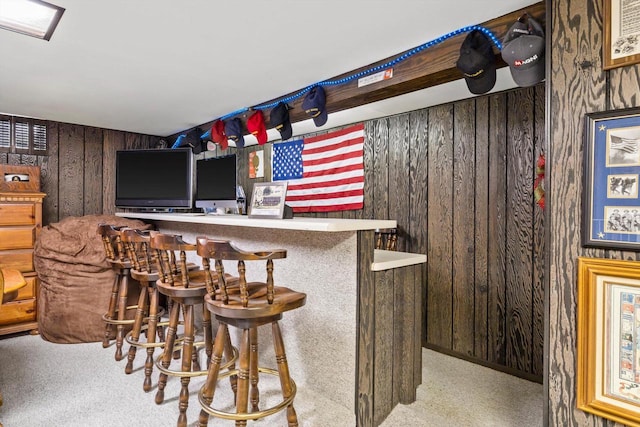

[545,0,640,427]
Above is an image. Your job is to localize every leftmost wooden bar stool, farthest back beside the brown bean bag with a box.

[98,224,137,361]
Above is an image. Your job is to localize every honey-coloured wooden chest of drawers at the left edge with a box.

[0,191,45,335]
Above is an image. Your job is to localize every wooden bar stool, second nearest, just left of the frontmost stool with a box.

[150,233,237,427]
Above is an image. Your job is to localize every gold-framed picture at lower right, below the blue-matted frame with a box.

[576,258,640,426]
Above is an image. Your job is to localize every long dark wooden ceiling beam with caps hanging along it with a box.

[191,2,545,135]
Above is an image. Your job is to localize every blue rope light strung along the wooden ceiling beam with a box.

[180,25,502,148]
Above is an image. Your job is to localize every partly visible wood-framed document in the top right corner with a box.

[602,0,640,70]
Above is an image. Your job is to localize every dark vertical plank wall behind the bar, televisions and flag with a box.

[0,85,545,382]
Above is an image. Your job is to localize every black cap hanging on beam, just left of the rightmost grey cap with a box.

[456,30,496,95]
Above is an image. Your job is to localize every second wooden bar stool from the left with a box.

[121,228,168,392]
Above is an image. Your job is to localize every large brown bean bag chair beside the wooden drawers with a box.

[34,215,151,343]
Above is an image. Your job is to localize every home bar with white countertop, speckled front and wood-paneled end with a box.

[116,212,426,427]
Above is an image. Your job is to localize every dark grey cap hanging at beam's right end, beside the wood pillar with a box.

[502,14,545,87]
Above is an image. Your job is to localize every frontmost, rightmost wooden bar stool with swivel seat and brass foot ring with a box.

[197,237,307,427]
